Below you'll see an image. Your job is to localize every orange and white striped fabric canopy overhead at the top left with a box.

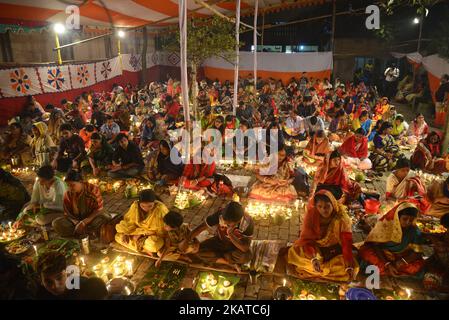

[0,0,327,27]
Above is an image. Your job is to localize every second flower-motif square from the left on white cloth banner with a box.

[37,66,72,93]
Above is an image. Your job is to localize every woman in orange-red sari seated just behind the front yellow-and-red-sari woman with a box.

[311,151,362,203]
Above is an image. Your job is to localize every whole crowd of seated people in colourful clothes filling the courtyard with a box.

[0,75,449,295]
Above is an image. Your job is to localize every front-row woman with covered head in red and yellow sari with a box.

[287,190,359,281]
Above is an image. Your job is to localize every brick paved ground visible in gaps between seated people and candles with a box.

[14,169,438,300]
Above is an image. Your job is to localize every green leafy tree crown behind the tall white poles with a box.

[162,16,243,67]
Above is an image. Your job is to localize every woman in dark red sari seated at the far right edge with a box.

[410,131,448,174]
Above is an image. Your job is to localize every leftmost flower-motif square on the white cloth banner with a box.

[0,68,42,98]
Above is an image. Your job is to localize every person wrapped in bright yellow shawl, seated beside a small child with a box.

[115,190,168,256]
